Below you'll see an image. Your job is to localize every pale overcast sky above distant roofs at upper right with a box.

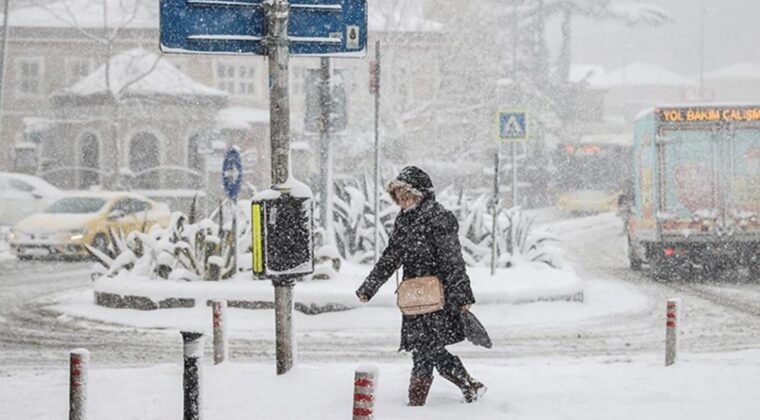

[573,0,760,77]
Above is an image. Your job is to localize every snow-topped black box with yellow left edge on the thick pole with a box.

[251,194,314,278]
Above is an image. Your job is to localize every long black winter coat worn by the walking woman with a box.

[356,196,475,351]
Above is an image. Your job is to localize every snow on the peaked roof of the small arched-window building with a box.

[64,48,227,97]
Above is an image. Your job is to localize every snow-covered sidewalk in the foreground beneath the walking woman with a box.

[0,350,760,420]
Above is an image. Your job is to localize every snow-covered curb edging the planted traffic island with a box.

[95,264,583,313]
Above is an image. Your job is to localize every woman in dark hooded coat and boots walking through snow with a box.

[356,166,486,406]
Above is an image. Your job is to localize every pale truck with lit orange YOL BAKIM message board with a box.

[626,105,760,280]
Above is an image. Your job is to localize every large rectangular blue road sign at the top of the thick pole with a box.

[160,0,367,57]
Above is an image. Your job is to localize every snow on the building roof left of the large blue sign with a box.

[8,0,159,28]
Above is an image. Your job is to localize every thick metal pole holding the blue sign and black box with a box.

[264,0,295,375]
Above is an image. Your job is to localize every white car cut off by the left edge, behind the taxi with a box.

[0,172,63,226]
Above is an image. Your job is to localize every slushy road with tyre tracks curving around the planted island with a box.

[0,214,760,374]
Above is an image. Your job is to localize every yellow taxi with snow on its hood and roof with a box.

[9,191,171,259]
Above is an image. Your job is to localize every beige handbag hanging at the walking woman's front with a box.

[396,276,444,315]
